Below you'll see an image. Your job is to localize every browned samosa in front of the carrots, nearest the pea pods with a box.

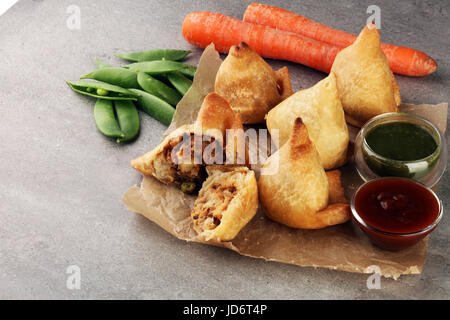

[215,42,292,124]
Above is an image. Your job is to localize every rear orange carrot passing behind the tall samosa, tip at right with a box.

[244,3,437,76]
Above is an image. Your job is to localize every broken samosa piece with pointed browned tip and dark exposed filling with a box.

[131,93,246,193]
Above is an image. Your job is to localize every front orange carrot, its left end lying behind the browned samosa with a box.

[183,11,341,72]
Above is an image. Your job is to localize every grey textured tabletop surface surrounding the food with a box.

[0,0,450,299]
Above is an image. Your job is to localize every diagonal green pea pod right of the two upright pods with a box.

[130,89,175,126]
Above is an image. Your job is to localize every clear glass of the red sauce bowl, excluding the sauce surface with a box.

[350,177,443,251]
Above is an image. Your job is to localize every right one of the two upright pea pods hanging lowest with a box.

[114,100,140,143]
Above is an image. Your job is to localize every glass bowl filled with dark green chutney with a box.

[355,112,447,187]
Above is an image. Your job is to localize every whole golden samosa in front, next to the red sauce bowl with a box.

[258,118,350,229]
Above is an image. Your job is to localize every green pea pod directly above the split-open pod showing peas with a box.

[80,67,140,89]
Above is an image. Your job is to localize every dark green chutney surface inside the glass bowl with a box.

[365,122,438,161]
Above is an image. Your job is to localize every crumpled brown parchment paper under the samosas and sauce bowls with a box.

[123,45,448,279]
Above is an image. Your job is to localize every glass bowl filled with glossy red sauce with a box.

[351,177,443,251]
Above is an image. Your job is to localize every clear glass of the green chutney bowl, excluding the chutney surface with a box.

[354,112,447,187]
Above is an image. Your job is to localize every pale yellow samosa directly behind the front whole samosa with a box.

[266,73,349,170]
